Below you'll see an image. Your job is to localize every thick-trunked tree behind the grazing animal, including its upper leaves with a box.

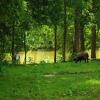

[73,0,90,54]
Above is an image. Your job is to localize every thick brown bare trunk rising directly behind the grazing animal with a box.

[73,7,85,54]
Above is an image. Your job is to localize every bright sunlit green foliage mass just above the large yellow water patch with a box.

[27,25,54,49]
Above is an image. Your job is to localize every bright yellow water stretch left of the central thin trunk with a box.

[19,51,54,63]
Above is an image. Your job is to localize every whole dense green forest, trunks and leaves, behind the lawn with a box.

[0,0,100,63]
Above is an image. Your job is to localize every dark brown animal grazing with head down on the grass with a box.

[74,52,89,63]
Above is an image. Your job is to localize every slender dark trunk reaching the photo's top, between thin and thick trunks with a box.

[62,0,67,62]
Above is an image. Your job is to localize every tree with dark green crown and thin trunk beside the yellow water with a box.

[29,0,62,63]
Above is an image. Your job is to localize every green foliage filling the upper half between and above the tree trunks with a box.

[0,0,100,61]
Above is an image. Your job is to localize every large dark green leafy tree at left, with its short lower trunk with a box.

[0,0,31,63]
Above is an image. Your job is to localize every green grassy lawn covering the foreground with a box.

[0,61,100,100]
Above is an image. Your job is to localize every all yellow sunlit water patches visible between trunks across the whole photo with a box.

[5,50,100,64]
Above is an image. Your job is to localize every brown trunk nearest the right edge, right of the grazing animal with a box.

[91,25,96,59]
